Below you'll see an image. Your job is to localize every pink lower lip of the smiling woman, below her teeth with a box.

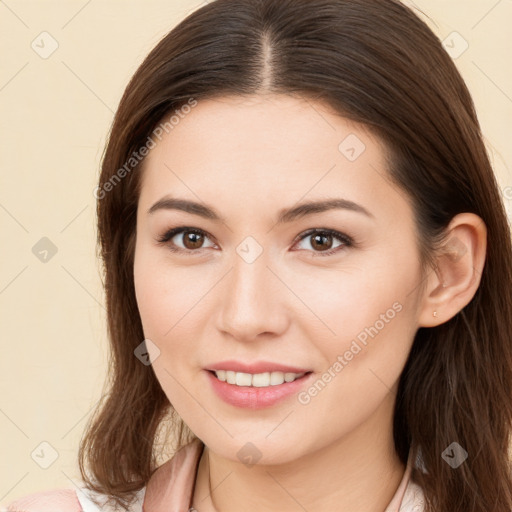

[206,367,313,409]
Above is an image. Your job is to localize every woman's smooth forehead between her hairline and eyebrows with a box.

[140,95,410,223]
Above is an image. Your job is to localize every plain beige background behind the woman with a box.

[0,0,512,503]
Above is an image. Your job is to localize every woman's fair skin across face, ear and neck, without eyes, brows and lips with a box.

[134,95,486,512]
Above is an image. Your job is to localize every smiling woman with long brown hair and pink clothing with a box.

[8,0,512,512]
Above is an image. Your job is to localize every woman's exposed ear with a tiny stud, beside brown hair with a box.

[418,213,487,327]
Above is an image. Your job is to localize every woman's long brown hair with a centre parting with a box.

[79,0,512,512]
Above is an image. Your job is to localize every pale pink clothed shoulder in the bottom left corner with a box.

[1,489,83,512]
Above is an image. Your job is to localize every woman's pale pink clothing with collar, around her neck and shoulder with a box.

[0,439,424,512]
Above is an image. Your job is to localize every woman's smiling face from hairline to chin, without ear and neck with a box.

[134,96,422,463]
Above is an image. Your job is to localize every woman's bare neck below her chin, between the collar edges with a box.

[194,394,405,512]
